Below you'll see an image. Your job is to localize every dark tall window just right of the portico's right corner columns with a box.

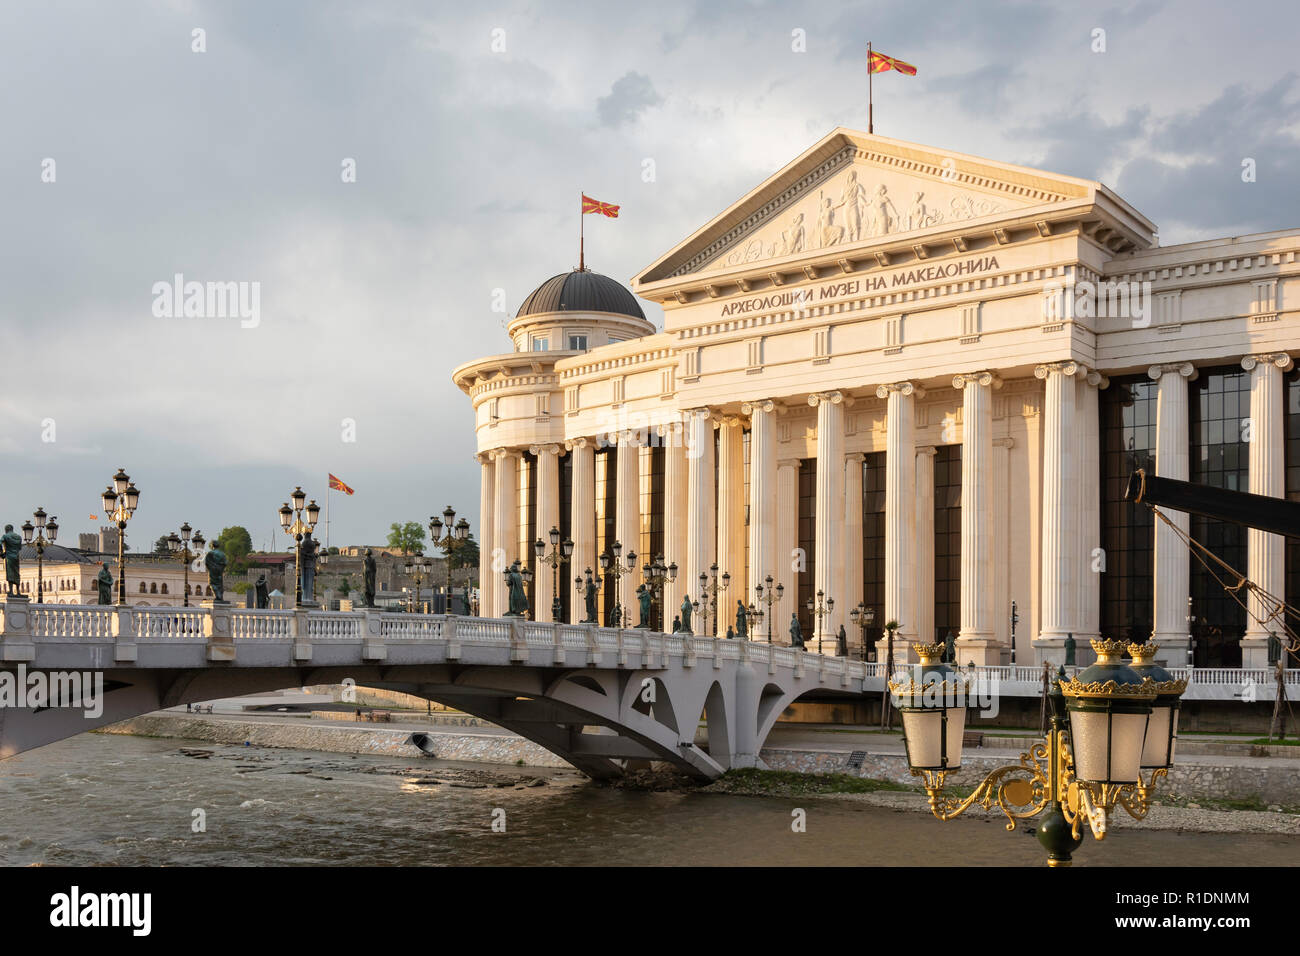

[1101,376,1158,641]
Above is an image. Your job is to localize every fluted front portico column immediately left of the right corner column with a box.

[953,372,1002,666]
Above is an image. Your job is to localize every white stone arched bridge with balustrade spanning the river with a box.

[0,601,1300,779]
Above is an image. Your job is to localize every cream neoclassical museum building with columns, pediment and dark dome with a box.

[454,129,1300,666]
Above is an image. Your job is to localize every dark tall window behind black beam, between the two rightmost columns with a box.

[1190,367,1251,667]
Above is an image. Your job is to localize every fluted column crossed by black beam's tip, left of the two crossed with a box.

[1147,362,1196,666]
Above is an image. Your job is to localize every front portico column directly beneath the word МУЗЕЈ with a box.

[809,392,844,654]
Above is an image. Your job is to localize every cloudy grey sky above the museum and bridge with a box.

[0,0,1300,548]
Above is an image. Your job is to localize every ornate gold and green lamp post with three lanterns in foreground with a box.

[889,640,1187,866]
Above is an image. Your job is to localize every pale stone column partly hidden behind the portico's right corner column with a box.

[1074,372,1110,648]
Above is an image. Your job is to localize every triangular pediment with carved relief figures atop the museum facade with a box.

[634,129,1104,286]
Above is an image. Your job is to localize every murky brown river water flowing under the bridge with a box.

[0,734,1300,866]
